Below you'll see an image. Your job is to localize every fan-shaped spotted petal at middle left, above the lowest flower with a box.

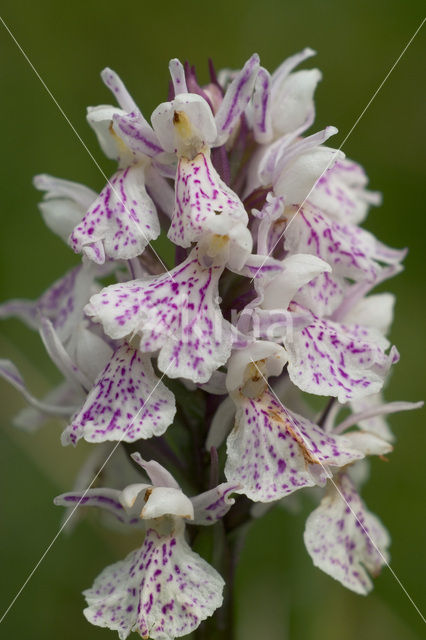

[62,343,176,444]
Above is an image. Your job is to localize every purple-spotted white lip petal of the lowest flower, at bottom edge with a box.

[84,529,224,640]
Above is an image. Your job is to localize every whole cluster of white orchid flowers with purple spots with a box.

[0,49,420,639]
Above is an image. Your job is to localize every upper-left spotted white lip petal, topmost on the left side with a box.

[69,165,160,264]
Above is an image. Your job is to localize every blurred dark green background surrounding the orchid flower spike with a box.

[0,0,426,640]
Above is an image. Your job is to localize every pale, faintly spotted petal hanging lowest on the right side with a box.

[304,474,390,595]
